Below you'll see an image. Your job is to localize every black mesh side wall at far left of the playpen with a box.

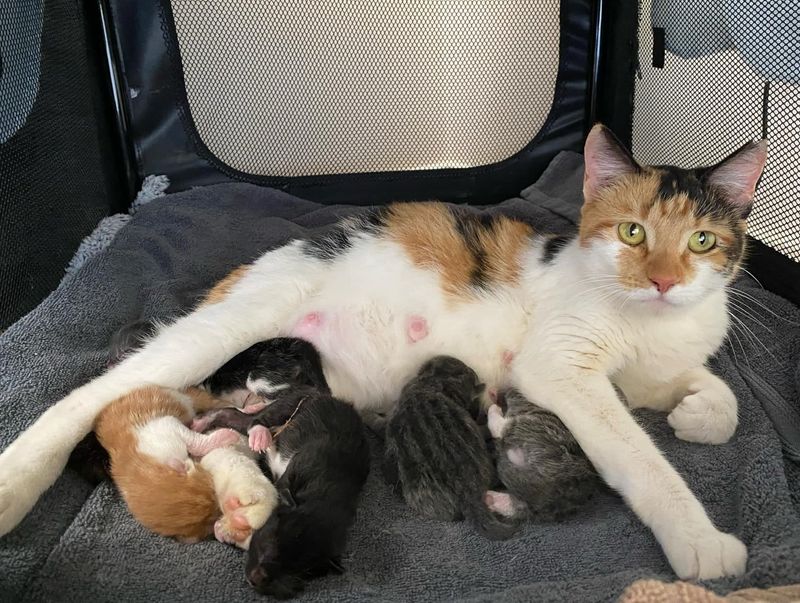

[0,0,122,329]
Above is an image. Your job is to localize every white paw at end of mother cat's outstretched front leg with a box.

[663,526,747,580]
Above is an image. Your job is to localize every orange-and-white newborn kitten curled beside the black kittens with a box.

[95,386,277,548]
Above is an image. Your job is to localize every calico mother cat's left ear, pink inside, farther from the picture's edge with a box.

[583,124,640,201]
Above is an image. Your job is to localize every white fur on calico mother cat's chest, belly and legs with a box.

[0,222,746,578]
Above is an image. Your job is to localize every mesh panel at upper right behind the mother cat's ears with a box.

[633,0,800,261]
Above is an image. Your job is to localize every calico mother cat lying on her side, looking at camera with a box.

[0,126,766,578]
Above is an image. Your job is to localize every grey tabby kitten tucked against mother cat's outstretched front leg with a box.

[486,390,603,521]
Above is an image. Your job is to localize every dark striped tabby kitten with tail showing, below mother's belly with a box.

[384,356,514,539]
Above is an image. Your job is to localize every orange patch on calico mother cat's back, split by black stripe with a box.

[386,202,532,296]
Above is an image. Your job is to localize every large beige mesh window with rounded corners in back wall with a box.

[172,0,560,176]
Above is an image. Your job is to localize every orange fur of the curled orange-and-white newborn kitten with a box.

[95,386,220,541]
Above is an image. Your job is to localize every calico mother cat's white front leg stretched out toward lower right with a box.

[514,353,747,579]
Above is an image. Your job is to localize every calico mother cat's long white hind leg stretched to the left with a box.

[0,243,322,535]
